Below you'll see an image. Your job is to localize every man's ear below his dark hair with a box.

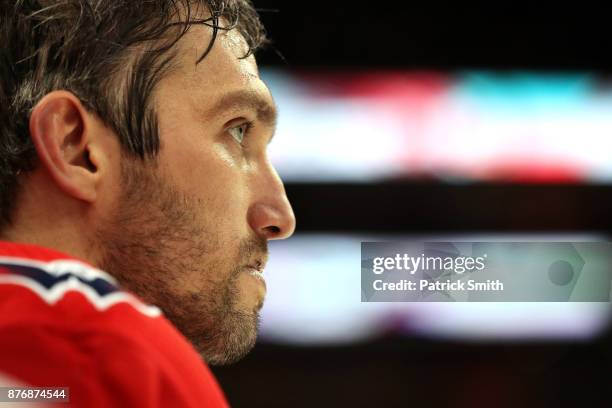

[30,91,99,203]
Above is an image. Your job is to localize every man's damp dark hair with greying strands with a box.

[0,0,266,229]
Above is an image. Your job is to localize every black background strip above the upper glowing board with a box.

[255,0,612,72]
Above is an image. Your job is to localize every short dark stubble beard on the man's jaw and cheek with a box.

[96,159,267,364]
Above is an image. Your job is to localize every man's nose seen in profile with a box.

[248,165,295,240]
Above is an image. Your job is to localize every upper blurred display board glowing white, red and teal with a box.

[262,69,612,183]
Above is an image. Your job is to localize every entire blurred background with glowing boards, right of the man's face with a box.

[214,0,612,407]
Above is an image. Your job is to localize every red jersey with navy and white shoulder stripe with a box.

[0,242,227,408]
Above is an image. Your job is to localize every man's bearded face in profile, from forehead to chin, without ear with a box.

[97,26,295,364]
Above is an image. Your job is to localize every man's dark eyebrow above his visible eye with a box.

[206,91,278,143]
